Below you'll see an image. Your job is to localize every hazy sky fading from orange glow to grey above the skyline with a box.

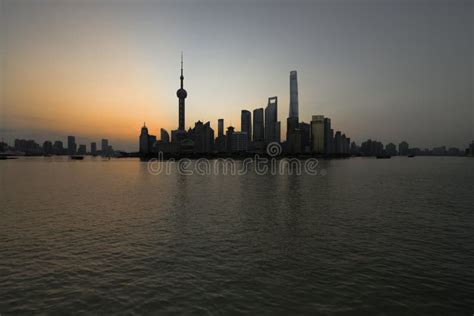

[0,0,474,151]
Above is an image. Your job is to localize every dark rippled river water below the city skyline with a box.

[0,157,474,316]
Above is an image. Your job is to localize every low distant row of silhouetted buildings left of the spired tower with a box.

[0,136,115,156]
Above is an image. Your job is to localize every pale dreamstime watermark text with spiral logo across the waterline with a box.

[147,142,327,176]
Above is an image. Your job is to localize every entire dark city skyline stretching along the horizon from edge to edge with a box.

[0,56,474,158]
